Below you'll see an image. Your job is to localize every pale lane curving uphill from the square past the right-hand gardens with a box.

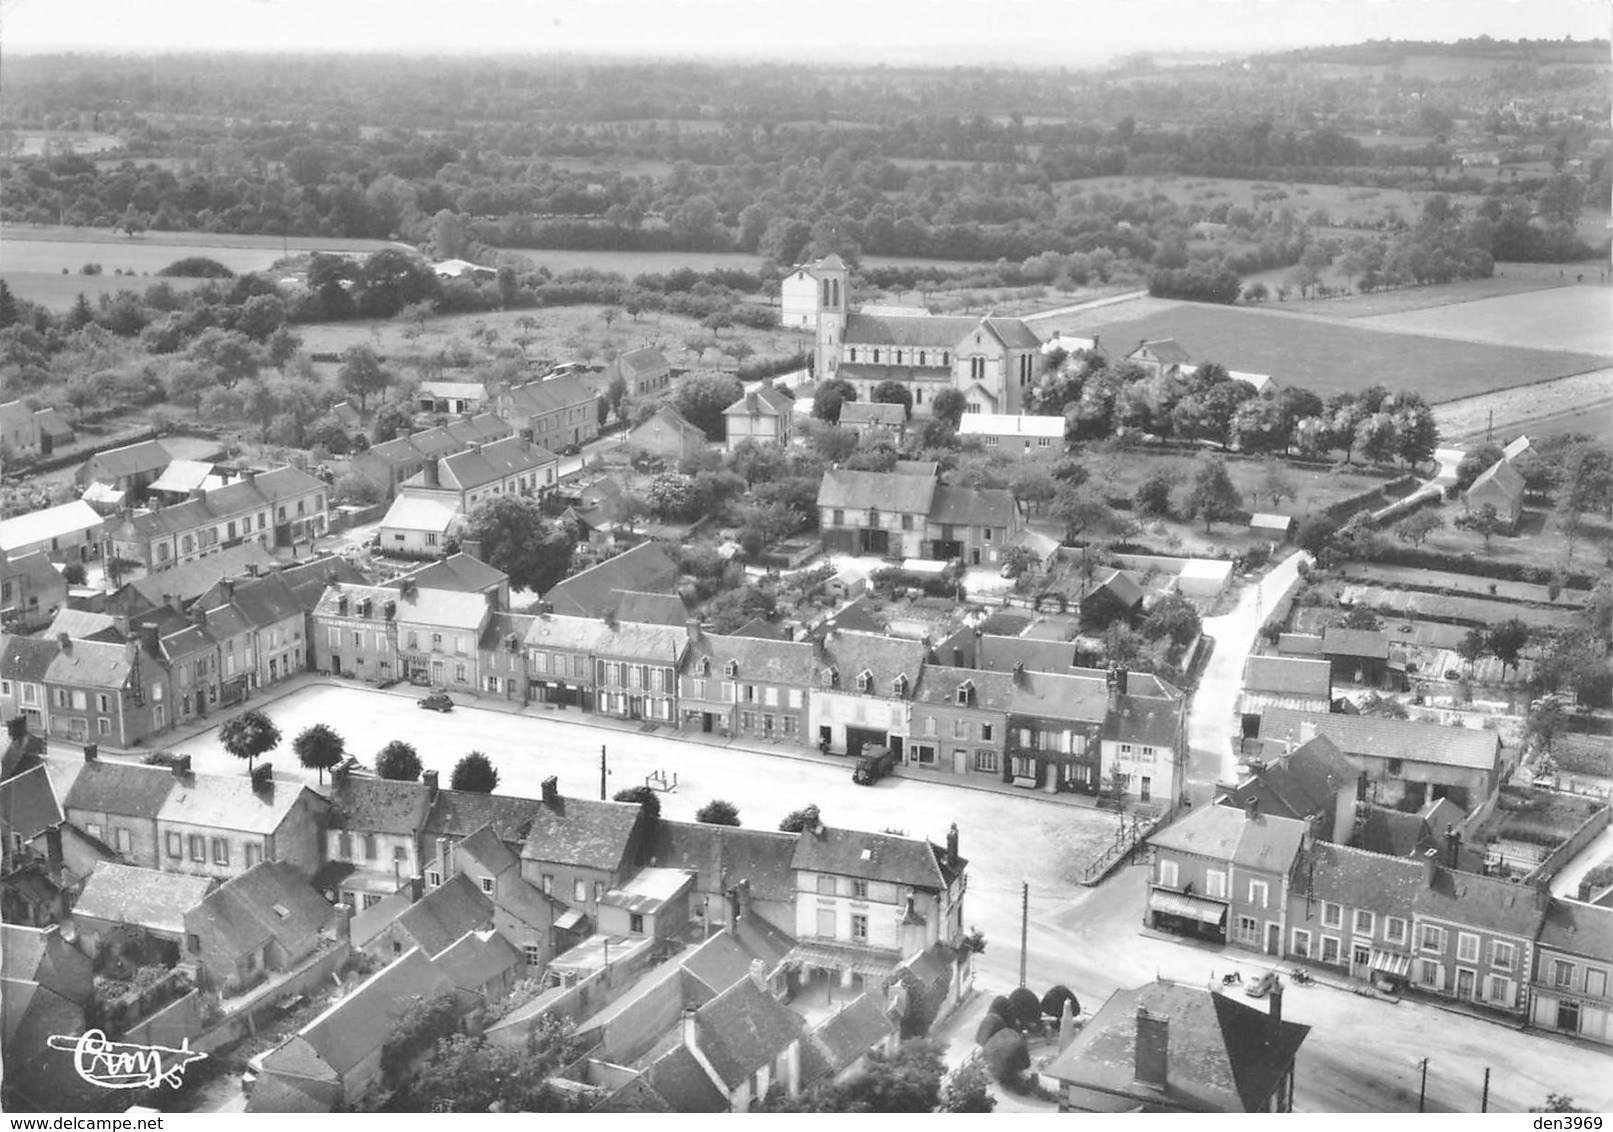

[1187,551,1310,806]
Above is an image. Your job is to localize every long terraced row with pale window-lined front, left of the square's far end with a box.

[103,468,329,571]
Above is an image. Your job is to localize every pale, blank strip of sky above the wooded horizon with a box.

[0,0,1613,66]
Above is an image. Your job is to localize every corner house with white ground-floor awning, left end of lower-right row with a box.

[1144,806,1310,958]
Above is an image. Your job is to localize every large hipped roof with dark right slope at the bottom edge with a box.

[1044,982,1310,1113]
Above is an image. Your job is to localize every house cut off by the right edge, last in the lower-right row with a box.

[1529,898,1613,1043]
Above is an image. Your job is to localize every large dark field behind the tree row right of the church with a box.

[1058,296,1607,403]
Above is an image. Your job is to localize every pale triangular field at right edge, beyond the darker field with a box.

[1355,285,1613,355]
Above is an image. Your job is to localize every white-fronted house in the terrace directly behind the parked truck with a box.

[808,629,929,758]
